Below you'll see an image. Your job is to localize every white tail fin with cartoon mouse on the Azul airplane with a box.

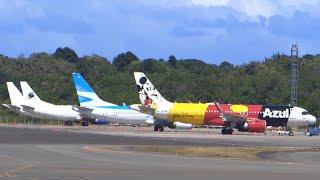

[134,72,170,109]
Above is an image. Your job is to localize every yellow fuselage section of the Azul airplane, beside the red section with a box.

[168,103,208,125]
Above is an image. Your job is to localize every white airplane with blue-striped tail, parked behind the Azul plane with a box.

[72,72,154,125]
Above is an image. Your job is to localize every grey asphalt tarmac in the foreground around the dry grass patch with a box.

[0,127,320,180]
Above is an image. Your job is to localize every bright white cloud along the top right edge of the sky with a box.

[137,0,320,20]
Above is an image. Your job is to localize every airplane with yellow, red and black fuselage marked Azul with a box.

[132,72,316,135]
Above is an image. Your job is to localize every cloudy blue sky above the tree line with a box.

[0,0,320,64]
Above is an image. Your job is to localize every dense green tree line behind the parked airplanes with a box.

[0,47,320,120]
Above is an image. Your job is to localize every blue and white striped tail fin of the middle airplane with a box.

[72,72,116,107]
